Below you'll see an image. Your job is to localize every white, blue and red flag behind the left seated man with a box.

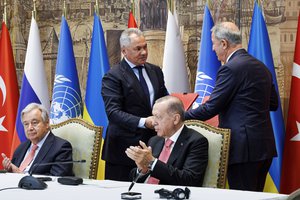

[12,18,50,149]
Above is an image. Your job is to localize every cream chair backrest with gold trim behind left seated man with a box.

[51,118,102,179]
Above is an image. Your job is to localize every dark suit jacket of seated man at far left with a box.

[12,132,74,176]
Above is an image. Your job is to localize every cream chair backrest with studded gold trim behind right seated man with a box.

[185,120,230,188]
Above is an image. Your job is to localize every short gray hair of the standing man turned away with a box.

[211,22,242,45]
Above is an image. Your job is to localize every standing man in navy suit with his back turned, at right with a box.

[185,22,278,191]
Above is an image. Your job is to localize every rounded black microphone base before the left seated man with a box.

[18,176,48,190]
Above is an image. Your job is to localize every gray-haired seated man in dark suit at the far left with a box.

[2,103,74,176]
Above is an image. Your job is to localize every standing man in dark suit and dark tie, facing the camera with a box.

[102,28,168,181]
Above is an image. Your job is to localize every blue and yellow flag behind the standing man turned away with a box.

[248,2,285,193]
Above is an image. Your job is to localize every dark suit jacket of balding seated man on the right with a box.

[131,126,208,187]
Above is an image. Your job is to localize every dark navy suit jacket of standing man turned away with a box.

[185,49,278,164]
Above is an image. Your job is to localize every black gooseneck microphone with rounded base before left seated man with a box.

[18,160,86,190]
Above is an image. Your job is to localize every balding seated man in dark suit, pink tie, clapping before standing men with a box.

[126,96,208,186]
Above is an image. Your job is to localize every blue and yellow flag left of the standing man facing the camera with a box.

[83,14,109,180]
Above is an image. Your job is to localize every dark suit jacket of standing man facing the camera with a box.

[102,59,168,166]
